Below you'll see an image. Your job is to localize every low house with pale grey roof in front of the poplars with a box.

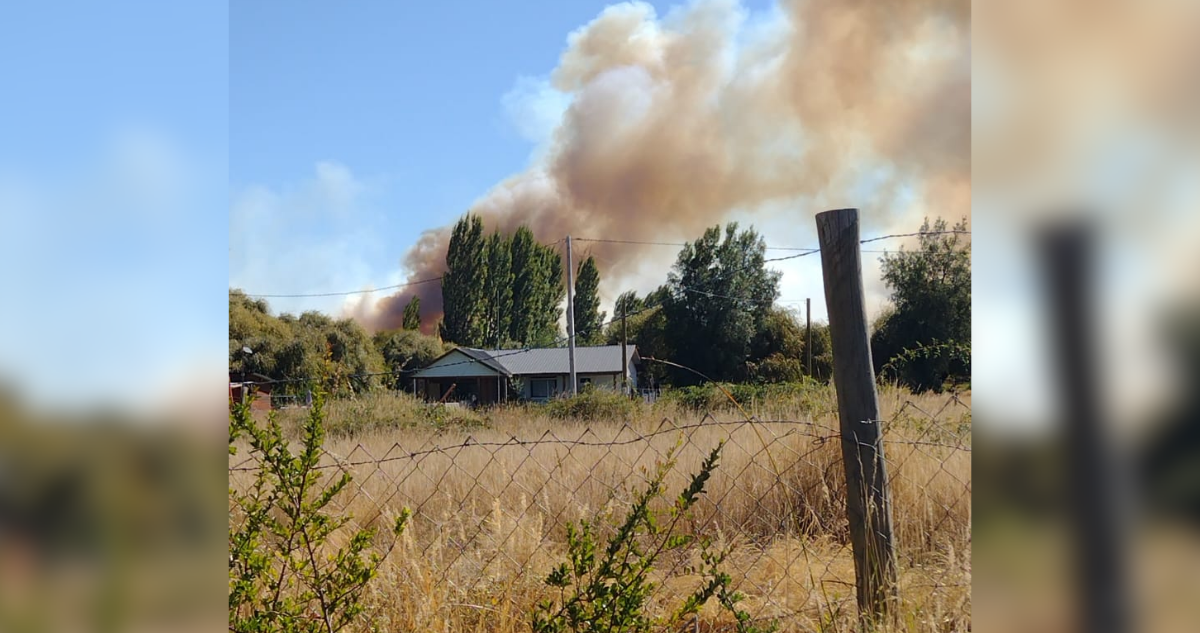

[412,345,641,404]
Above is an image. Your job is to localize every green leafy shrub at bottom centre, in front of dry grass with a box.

[533,442,774,633]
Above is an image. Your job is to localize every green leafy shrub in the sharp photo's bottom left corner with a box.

[229,393,409,633]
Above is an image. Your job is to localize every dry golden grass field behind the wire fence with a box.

[230,386,971,633]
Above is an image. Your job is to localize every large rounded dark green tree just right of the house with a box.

[662,222,780,384]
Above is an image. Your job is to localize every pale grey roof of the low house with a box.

[414,345,640,378]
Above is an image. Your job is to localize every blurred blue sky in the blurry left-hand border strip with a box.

[0,0,229,406]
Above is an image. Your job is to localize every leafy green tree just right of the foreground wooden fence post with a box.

[871,218,971,391]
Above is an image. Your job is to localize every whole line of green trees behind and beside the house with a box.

[229,218,971,392]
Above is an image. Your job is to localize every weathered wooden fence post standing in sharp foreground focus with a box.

[816,209,899,629]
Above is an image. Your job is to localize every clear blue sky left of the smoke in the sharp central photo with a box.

[229,0,770,188]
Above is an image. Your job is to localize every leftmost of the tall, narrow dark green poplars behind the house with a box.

[440,213,487,346]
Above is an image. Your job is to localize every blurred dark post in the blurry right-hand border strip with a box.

[1038,224,1133,633]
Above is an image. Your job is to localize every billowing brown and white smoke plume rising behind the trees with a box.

[359,0,971,328]
